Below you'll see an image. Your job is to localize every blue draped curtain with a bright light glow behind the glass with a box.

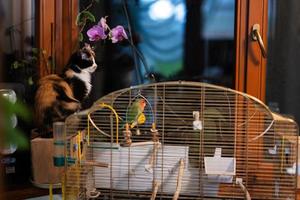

[131,0,185,78]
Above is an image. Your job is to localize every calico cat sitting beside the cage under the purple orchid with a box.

[35,44,97,137]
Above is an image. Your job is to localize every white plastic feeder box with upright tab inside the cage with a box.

[204,148,236,183]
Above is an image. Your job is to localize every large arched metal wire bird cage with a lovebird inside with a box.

[64,81,298,200]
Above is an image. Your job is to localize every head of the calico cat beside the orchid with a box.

[67,44,97,73]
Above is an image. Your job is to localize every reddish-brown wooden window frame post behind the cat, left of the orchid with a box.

[35,0,79,77]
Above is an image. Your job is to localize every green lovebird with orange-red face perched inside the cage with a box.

[127,99,146,128]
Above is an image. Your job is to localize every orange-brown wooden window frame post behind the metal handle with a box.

[235,0,268,102]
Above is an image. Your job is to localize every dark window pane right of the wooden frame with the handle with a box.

[266,0,300,124]
